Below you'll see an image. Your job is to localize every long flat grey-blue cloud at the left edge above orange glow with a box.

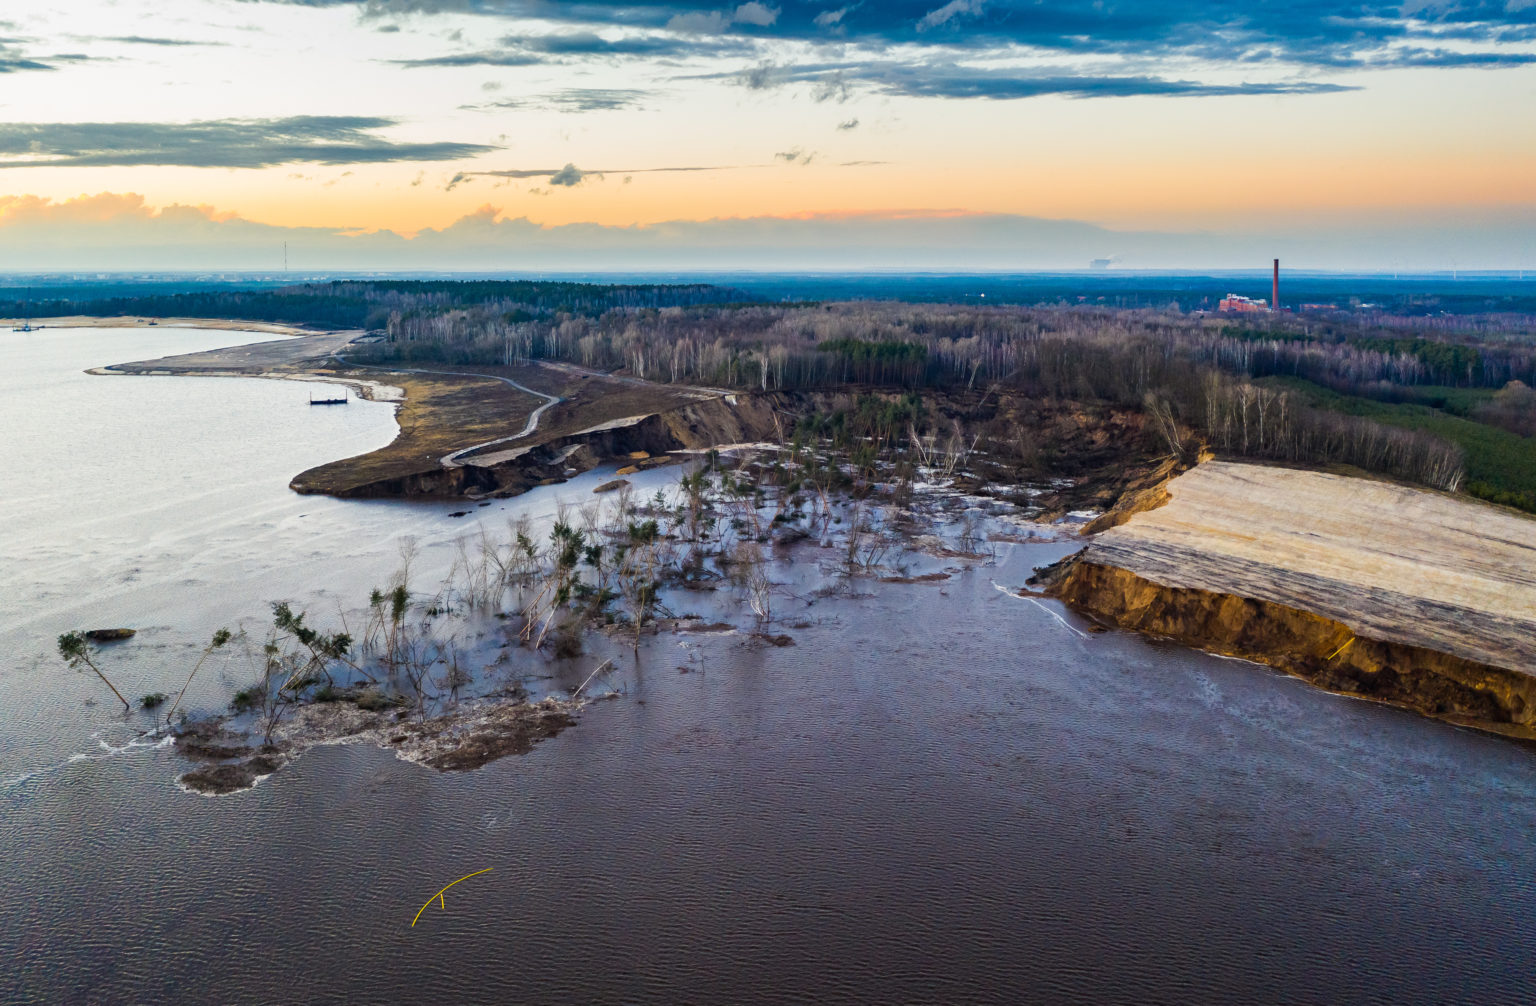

[0,115,496,167]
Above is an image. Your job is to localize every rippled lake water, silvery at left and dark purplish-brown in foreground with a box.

[0,330,1536,1003]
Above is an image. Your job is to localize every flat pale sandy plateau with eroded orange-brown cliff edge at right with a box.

[1040,461,1536,739]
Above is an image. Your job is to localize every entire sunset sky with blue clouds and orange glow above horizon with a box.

[0,0,1536,272]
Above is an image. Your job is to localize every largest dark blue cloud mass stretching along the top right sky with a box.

[227,0,1536,111]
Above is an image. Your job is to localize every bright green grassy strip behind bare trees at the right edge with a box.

[1258,378,1536,513]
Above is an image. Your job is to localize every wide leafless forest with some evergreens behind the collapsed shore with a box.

[345,294,1536,511]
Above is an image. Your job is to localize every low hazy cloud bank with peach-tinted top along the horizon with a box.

[0,194,1536,272]
